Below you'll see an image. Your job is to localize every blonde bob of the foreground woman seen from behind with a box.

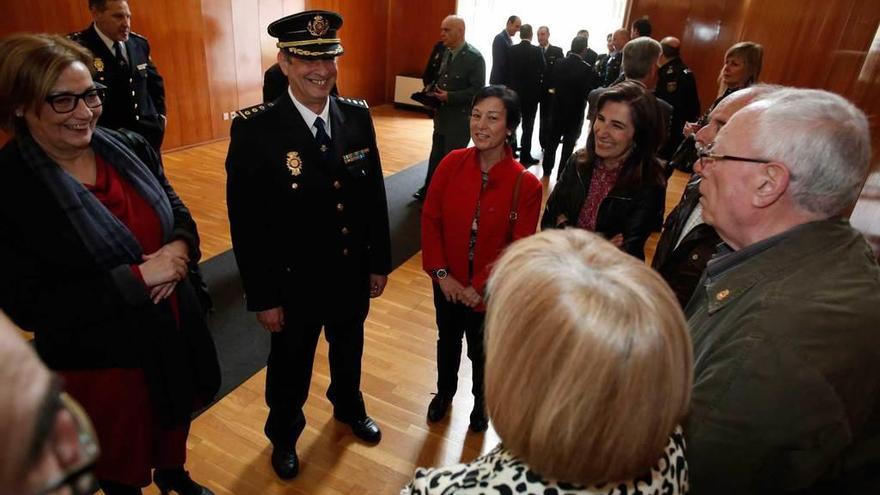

[486,229,693,485]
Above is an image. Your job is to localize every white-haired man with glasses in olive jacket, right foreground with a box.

[685,89,880,494]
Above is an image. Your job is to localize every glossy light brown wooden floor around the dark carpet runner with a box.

[138,106,684,495]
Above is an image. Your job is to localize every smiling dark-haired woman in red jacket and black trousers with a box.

[422,86,541,432]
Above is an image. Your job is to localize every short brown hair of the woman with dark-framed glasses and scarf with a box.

[0,34,93,132]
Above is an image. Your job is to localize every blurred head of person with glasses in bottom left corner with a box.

[0,312,99,495]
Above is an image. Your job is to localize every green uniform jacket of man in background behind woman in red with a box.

[434,42,486,134]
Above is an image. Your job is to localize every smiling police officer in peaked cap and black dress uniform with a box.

[226,10,391,479]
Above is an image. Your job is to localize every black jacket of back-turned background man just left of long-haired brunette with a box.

[547,53,599,134]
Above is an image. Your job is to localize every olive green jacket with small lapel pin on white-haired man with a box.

[685,220,880,495]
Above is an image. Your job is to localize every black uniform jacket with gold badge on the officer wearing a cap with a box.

[226,96,391,320]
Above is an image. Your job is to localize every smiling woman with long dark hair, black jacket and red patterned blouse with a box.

[541,81,666,259]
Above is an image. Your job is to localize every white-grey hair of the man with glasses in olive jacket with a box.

[746,88,871,218]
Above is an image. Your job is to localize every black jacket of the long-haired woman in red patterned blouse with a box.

[541,153,666,259]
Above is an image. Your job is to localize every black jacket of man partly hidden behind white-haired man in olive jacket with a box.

[651,176,721,309]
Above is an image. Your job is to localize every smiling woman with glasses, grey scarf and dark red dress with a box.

[0,34,219,495]
